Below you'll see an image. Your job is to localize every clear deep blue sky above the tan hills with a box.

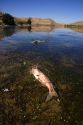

[0,0,83,23]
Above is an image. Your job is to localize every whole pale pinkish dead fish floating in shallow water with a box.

[30,66,59,102]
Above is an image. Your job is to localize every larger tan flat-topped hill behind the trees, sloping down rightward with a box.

[0,12,63,27]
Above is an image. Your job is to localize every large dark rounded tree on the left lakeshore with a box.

[2,13,15,25]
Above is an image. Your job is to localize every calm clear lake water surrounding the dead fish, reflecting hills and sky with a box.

[0,26,83,125]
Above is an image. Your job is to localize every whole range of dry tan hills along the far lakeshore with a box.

[0,12,83,28]
